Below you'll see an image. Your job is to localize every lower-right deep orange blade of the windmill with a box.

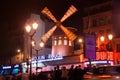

[60,25,77,41]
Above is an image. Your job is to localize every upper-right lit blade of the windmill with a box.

[60,5,77,22]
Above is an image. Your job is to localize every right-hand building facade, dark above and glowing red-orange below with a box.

[83,0,120,64]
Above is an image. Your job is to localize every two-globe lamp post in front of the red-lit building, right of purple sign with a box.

[100,34,113,64]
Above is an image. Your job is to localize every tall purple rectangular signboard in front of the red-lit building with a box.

[84,34,96,59]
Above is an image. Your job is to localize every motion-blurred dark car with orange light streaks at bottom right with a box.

[83,66,120,80]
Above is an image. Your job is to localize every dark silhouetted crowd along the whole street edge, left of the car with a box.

[0,65,88,80]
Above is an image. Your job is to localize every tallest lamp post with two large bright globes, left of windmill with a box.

[25,22,38,79]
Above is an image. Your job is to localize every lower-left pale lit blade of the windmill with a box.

[41,25,57,43]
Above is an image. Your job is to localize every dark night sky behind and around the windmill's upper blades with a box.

[0,0,109,57]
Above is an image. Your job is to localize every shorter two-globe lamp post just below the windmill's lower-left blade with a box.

[32,40,44,74]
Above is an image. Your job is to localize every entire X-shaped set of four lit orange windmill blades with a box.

[41,5,77,43]
